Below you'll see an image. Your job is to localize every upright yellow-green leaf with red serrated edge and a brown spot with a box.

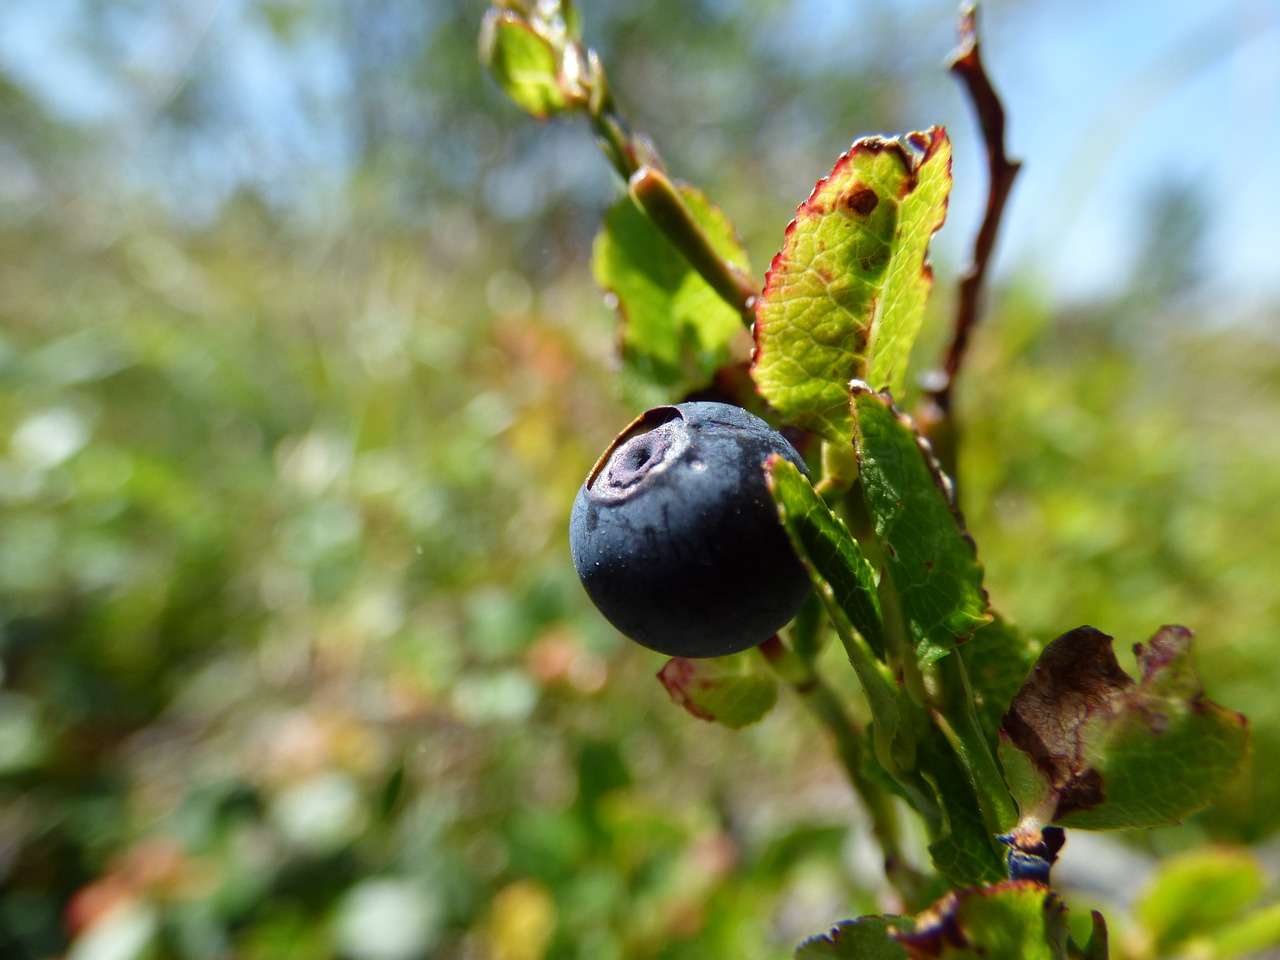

[751,128,951,443]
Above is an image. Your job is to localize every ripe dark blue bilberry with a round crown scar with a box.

[570,403,810,657]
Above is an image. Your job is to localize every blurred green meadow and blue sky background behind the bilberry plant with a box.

[0,0,1280,960]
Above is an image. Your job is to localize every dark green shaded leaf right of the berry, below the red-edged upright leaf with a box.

[852,387,991,663]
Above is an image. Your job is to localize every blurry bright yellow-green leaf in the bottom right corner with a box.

[1134,847,1267,956]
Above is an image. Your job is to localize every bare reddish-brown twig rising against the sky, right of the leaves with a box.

[928,4,1021,419]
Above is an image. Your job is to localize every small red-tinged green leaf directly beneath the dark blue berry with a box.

[658,652,778,730]
